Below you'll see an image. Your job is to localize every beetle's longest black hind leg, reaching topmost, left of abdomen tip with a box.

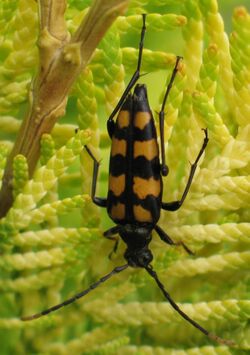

[107,14,146,138]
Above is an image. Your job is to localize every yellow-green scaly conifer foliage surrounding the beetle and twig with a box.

[0,0,250,355]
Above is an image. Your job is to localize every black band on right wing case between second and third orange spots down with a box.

[132,155,160,180]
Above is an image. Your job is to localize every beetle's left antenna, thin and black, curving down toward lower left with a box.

[21,264,128,321]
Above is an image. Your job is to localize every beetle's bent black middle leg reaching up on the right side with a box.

[161,129,208,211]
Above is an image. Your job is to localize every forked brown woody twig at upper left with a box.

[0,0,129,218]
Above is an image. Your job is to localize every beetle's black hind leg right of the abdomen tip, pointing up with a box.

[159,56,182,176]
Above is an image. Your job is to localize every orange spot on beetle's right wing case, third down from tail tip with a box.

[133,176,161,200]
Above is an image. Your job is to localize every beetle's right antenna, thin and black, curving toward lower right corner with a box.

[144,265,235,346]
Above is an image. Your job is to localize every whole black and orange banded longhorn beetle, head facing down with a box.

[22,14,233,345]
